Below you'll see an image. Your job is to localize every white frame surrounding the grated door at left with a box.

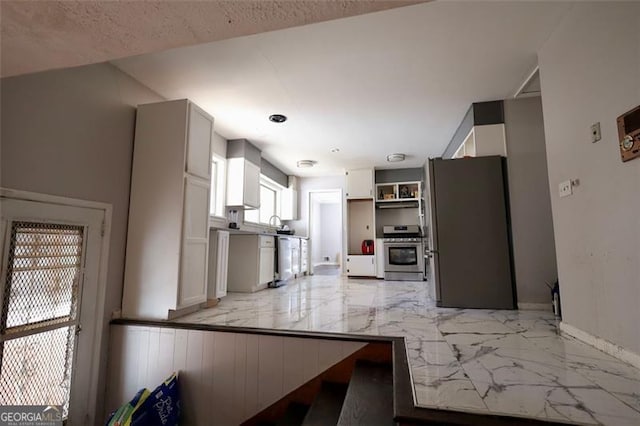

[0,187,113,424]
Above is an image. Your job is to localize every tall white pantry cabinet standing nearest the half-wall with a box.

[122,100,213,319]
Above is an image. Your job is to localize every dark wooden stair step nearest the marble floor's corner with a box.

[337,361,395,426]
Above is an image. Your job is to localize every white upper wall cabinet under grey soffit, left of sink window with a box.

[227,158,260,208]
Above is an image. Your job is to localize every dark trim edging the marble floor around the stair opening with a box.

[110,318,574,426]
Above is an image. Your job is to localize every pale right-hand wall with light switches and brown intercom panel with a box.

[539,2,640,353]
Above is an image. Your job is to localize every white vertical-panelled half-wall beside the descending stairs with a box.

[106,325,366,425]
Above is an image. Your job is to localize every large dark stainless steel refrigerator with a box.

[427,156,516,309]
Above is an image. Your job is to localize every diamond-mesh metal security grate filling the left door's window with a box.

[0,222,84,416]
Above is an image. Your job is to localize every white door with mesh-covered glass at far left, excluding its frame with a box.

[0,198,104,425]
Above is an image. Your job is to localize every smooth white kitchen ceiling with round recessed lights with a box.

[112,1,571,176]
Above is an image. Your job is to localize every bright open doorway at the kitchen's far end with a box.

[308,189,342,276]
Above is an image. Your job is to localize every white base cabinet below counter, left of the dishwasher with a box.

[227,234,275,293]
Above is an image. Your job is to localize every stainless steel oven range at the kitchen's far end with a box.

[382,225,424,281]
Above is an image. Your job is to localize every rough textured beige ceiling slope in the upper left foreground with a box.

[0,0,422,77]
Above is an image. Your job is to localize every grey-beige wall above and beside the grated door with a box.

[0,64,162,413]
